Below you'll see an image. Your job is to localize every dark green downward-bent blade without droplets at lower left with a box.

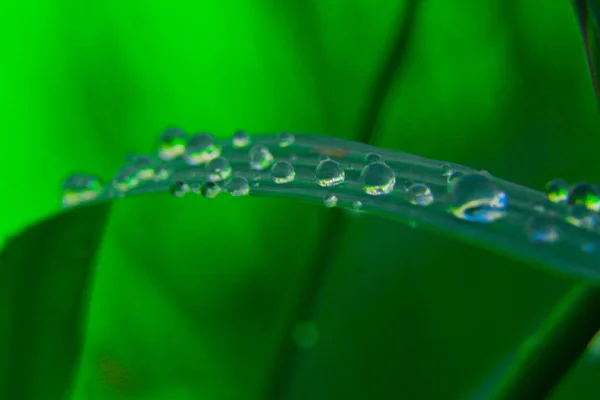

[0,203,110,400]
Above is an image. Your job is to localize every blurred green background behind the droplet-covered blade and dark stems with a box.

[0,0,600,400]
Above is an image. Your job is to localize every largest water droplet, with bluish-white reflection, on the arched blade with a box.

[449,174,508,223]
